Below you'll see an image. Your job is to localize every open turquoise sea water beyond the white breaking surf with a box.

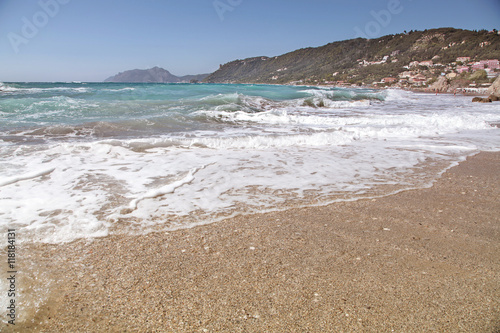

[0,83,385,141]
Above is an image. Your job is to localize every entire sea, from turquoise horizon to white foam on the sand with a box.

[0,82,500,244]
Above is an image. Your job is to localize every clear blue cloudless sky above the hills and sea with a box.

[0,0,500,82]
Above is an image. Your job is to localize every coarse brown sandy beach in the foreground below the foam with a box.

[3,152,500,332]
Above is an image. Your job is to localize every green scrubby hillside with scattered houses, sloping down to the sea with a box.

[205,28,500,85]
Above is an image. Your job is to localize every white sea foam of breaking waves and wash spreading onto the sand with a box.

[0,89,500,243]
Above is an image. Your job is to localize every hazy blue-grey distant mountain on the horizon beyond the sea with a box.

[104,67,210,83]
